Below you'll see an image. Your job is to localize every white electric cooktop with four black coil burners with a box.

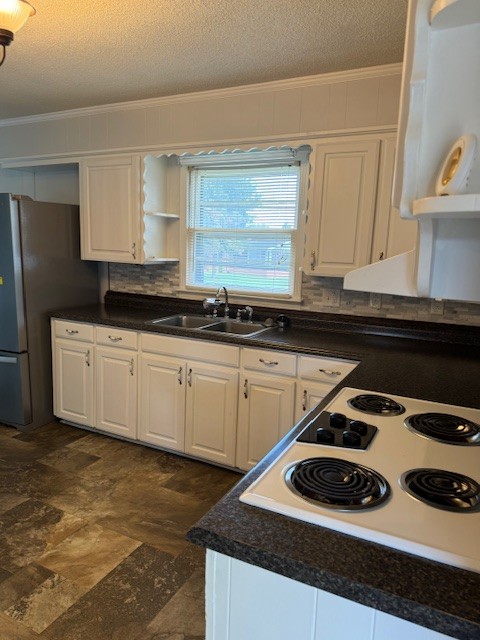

[240,387,480,572]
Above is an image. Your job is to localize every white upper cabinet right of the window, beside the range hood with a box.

[304,132,417,276]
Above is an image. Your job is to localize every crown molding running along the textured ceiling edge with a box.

[0,63,402,127]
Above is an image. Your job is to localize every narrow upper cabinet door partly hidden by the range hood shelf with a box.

[370,134,418,262]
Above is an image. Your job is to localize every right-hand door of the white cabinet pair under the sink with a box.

[185,363,238,466]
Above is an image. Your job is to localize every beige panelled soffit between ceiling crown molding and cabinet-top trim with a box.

[0,65,401,161]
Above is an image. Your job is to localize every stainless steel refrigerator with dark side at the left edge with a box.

[0,193,99,431]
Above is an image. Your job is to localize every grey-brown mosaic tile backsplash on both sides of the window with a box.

[109,263,480,326]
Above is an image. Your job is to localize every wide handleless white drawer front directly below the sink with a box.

[142,333,240,367]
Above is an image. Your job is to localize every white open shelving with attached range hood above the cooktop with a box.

[344,0,480,302]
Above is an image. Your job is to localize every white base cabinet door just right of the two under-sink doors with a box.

[236,371,295,469]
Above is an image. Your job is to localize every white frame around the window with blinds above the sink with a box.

[180,144,312,304]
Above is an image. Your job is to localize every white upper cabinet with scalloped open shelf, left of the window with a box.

[80,154,181,264]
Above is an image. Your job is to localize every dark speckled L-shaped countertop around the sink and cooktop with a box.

[52,294,480,640]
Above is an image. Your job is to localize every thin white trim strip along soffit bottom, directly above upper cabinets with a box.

[0,123,397,169]
